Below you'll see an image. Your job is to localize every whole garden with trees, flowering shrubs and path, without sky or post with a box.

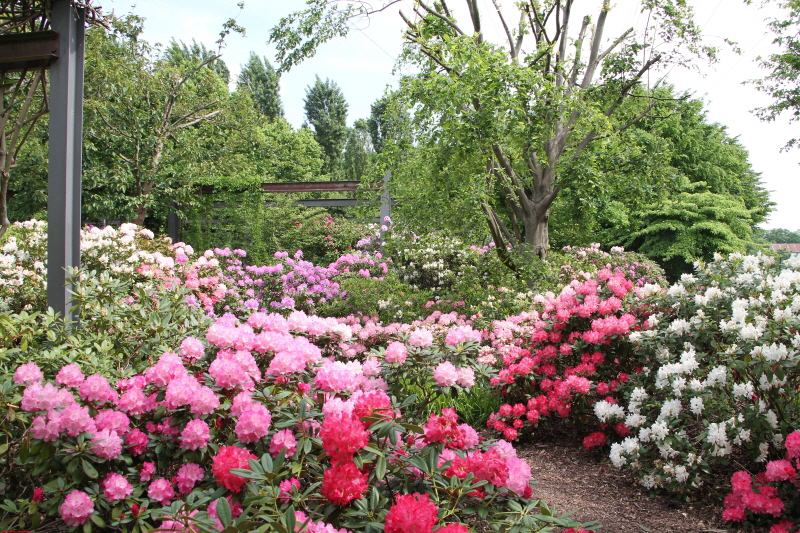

[0,0,800,533]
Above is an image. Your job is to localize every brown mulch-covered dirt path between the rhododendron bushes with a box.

[518,440,755,533]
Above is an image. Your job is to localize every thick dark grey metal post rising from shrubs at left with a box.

[47,0,86,321]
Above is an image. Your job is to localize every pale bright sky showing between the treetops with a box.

[101,0,800,230]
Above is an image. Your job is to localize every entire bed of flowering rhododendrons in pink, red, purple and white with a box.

[0,219,800,533]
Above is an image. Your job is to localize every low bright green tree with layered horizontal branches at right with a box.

[626,182,753,279]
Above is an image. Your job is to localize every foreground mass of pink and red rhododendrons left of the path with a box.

[0,312,592,532]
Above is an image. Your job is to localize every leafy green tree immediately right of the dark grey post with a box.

[84,17,229,224]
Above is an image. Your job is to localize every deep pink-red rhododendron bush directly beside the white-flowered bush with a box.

[480,268,646,440]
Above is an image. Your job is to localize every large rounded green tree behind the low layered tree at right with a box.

[554,86,774,249]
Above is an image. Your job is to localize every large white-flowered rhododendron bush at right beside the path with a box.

[608,254,800,490]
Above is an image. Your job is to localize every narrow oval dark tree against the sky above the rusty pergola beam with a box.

[303,76,348,174]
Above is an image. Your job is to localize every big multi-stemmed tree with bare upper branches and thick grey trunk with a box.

[271,0,713,262]
